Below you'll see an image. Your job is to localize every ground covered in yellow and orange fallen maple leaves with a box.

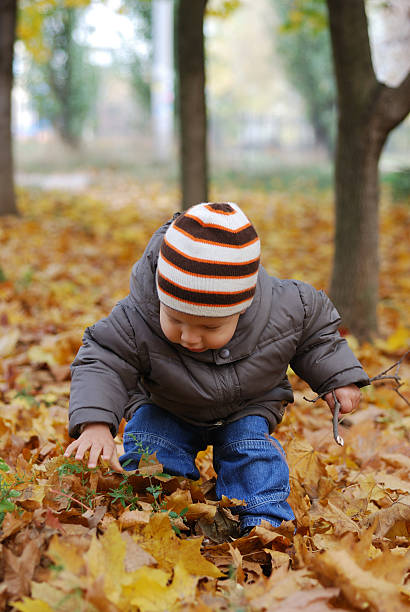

[0,182,410,612]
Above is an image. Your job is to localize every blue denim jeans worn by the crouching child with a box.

[120,404,294,530]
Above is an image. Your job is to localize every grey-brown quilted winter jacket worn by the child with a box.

[69,213,369,438]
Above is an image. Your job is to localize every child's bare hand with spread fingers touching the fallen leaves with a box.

[64,423,123,472]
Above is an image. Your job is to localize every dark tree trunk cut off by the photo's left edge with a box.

[0,0,18,215]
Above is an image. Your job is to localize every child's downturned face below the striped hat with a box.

[160,303,242,353]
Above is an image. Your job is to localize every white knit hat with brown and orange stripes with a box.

[157,202,260,317]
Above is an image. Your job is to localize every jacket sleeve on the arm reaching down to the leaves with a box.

[69,302,138,438]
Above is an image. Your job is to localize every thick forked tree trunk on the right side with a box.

[327,0,410,340]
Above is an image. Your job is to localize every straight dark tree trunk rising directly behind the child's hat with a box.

[177,0,208,209]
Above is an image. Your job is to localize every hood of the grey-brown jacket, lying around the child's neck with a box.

[130,218,272,363]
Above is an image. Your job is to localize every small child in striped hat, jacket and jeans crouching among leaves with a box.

[65,203,369,532]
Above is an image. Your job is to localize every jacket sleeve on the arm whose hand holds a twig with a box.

[290,282,369,394]
